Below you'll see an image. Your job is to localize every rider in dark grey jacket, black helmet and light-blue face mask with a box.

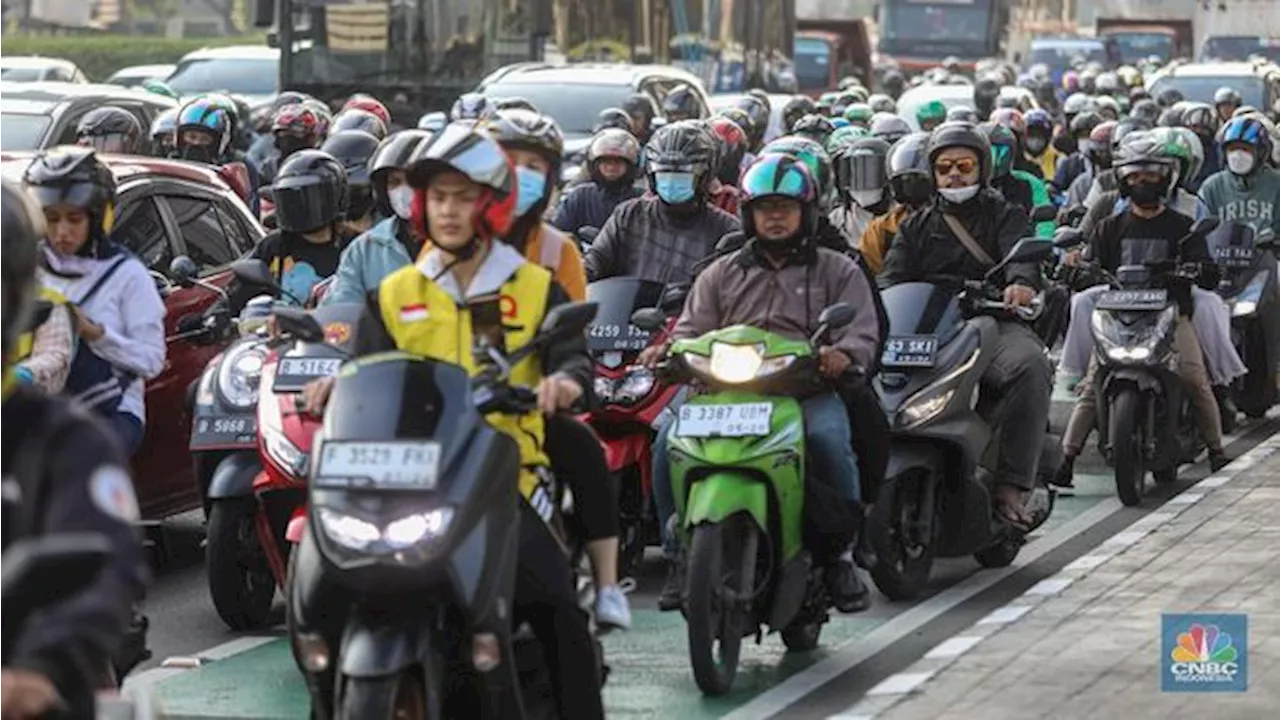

[585,120,741,283]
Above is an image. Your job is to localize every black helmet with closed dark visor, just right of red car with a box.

[271,150,348,232]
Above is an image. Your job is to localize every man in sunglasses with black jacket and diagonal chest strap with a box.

[877,123,1052,525]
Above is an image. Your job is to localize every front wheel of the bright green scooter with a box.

[685,515,759,696]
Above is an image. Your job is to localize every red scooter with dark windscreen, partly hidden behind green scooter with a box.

[580,278,687,577]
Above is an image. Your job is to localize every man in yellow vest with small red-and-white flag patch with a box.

[305,124,604,720]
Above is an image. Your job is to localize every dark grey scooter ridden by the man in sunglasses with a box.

[868,238,1062,600]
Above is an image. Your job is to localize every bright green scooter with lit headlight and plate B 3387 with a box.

[650,304,854,696]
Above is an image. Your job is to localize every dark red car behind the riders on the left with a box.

[0,152,265,520]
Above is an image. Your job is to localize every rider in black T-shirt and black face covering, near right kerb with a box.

[1055,141,1230,484]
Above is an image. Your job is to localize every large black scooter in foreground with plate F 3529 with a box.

[288,304,603,720]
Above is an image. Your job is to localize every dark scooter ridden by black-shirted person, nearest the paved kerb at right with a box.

[1092,218,1219,506]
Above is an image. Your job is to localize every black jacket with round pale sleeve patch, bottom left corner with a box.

[0,388,150,717]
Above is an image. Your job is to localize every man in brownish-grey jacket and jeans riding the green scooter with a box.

[641,155,879,612]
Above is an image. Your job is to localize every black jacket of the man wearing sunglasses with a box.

[877,190,1041,288]
